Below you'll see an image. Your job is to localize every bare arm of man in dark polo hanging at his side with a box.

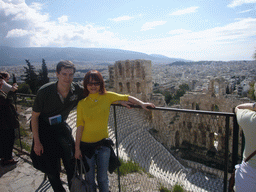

[31,111,44,156]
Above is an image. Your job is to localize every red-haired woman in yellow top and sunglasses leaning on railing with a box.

[75,70,155,192]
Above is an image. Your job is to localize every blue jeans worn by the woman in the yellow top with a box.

[84,146,110,192]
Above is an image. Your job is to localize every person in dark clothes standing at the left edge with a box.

[0,75,18,166]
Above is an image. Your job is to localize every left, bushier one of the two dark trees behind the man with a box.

[22,59,38,94]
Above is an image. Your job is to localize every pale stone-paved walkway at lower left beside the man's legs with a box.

[0,152,68,192]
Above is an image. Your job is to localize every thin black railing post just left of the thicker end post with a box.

[223,116,229,192]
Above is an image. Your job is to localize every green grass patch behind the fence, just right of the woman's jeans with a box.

[116,159,143,176]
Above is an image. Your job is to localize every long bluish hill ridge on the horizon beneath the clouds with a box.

[0,46,188,66]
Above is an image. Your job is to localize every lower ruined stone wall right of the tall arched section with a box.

[153,78,251,162]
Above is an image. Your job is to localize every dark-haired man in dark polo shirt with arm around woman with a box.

[31,61,83,192]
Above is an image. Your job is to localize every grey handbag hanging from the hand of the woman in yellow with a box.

[70,158,91,192]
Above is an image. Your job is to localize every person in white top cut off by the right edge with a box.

[235,103,256,192]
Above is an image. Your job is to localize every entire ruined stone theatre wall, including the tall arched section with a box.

[109,60,250,166]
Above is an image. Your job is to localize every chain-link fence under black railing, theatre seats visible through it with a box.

[15,94,239,192]
